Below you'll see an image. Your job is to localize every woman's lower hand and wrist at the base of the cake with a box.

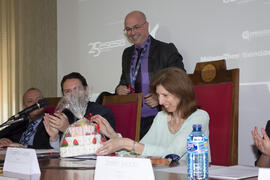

[96,137,133,156]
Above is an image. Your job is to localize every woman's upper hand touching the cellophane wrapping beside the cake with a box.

[91,115,118,139]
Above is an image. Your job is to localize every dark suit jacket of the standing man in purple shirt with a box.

[118,36,185,86]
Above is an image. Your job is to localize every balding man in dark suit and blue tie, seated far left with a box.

[0,88,51,149]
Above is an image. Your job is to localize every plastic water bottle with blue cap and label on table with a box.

[187,124,208,180]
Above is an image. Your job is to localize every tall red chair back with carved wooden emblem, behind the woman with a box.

[189,60,239,166]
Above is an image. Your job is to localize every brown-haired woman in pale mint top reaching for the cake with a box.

[92,67,210,160]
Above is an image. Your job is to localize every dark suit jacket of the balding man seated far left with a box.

[0,116,52,149]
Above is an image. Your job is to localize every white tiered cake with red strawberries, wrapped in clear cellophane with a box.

[60,118,105,157]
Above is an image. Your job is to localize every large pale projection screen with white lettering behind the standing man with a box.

[57,0,270,165]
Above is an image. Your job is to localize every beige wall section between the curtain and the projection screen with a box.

[16,0,57,96]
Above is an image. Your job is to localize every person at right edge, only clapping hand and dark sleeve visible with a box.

[251,121,270,167]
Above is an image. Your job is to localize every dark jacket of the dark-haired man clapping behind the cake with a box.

[63,101,115,129]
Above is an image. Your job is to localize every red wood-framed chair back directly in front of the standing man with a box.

[102,93,142,141]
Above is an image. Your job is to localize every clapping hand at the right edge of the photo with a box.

[251,126,270,156]
